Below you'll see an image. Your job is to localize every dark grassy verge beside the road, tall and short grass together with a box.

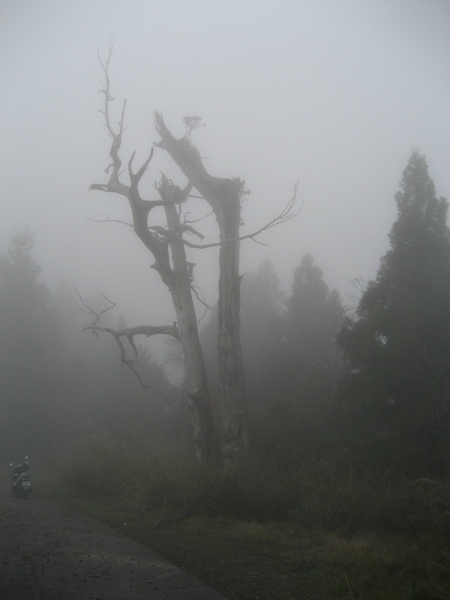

[39,448,450,600]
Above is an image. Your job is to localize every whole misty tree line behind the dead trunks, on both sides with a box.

[0,151,450,475]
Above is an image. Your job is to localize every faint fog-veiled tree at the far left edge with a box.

[0,231,59,452]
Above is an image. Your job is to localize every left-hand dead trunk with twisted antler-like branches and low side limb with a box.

[90,51,219,464]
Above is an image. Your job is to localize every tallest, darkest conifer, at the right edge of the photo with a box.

[339,151,450,470]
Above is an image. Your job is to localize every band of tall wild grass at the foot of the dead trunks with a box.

[59,442,450,534]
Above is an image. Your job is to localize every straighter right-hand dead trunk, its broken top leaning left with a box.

[155,112,296,461]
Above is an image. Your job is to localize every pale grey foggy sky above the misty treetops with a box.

[0,0,450,325]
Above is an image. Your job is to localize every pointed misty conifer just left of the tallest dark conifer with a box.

[250,255,344,466]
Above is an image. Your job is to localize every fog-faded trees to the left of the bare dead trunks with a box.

[0,231,175,462]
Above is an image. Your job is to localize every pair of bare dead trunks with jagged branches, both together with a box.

[91,48,295,463]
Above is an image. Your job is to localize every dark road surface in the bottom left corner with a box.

[0,494,225,600]
